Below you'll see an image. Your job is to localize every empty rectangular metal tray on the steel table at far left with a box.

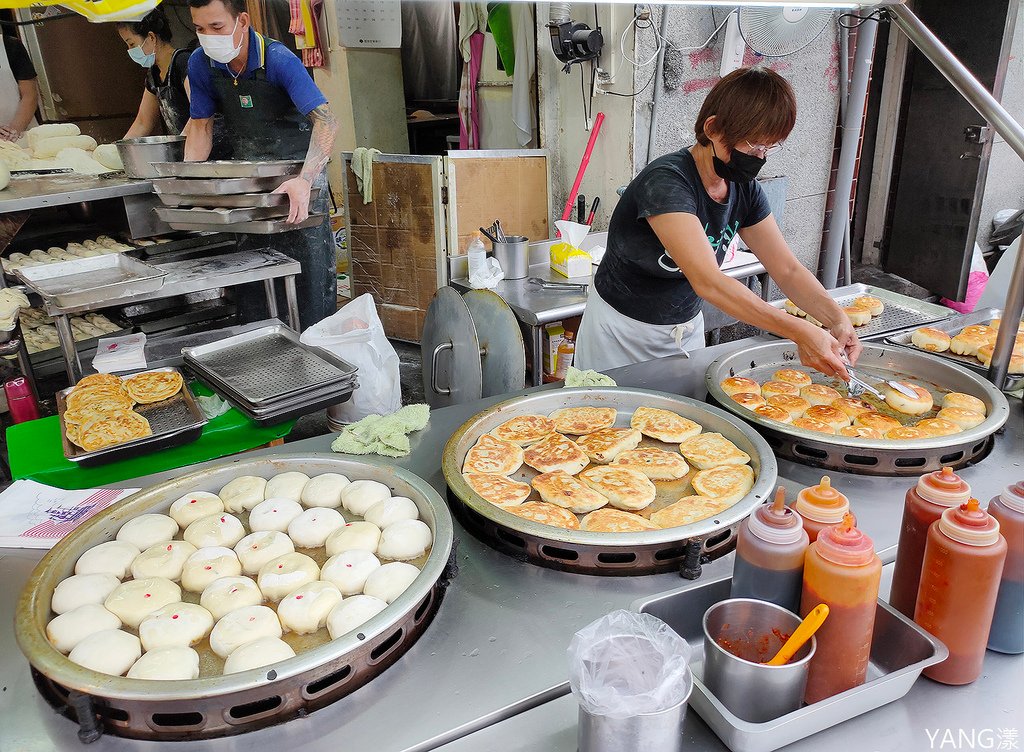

[14,253,167,307]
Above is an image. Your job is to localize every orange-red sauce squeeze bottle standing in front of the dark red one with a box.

[913,499,1007,684]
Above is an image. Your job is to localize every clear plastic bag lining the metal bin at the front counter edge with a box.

[566,610,691,718]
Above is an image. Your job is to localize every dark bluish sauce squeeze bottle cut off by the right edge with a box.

[988,481,1024,654]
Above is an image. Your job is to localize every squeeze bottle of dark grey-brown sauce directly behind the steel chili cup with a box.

[729,486,808,614]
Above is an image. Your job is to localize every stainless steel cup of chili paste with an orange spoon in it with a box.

[703,598,817,723]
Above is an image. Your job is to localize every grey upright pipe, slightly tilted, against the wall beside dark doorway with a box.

[821,12,879,290]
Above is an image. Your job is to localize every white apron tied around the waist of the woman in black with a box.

[573,287,705,371]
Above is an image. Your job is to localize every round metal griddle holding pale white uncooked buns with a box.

[14,454,454,741]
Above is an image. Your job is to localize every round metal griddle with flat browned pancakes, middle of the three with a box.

[441,387,777,576]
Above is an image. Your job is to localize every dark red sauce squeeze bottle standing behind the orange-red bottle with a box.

[889,467,971,619]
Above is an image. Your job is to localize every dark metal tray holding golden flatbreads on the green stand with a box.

[56,368,207,467]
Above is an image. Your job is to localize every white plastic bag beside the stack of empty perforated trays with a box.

[299,293,401,423]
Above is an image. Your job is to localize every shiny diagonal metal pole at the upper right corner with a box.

[888,5,1024,159]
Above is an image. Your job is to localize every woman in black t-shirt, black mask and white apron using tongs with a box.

[575,68,861,379]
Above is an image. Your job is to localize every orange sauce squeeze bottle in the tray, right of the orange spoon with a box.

[800,512,882,704]
